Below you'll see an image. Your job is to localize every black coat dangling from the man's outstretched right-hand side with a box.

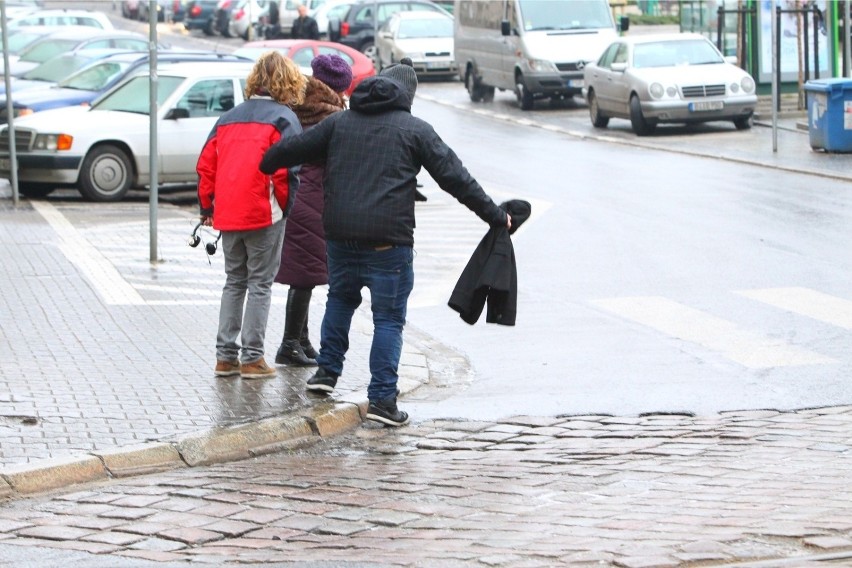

[448,199,532,325]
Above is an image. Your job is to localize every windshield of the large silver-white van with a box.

[519,0,613,31]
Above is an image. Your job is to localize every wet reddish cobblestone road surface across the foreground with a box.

[0,407,852,568]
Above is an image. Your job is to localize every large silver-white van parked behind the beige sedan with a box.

[453,0,629,110]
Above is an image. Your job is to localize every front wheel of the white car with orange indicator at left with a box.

[79,144,133,202]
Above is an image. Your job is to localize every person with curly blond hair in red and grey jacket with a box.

[196,51,306,379]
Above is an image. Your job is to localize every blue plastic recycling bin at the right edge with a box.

[805,79,852,152]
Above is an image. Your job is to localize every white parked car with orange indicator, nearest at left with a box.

[0,61,254,201]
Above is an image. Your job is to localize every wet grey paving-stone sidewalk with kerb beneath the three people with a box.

[0,193,428,496]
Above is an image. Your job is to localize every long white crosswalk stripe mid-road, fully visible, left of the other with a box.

[593,296,836,369]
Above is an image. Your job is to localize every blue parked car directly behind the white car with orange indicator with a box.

[0,51,251,124]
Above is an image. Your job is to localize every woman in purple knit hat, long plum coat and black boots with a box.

[275,55,352,367]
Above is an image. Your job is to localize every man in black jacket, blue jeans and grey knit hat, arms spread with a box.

[260,60,511,426]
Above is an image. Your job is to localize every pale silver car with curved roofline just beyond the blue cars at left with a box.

[9,26,163,77]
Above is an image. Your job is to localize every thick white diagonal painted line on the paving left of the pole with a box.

[31,201,145,306]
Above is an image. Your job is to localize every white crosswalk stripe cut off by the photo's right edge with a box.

[737,288,852,329]
